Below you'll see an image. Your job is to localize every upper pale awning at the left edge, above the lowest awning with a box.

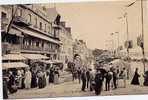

[2,54,26,60]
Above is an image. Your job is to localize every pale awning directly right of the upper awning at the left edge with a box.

[21,54,49,60]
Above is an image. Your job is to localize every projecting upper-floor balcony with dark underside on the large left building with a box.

[14,16,31,26]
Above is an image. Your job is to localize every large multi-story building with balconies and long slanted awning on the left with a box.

[1,5,60,59]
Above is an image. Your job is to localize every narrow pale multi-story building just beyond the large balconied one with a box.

[60,22,73,67]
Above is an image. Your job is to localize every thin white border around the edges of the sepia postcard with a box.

[0,0,148,100]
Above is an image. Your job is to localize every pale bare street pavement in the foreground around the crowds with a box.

[9,73,148,99]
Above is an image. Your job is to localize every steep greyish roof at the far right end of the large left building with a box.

[47,8,58,22]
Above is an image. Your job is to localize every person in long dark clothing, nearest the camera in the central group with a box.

[95,70,103,95]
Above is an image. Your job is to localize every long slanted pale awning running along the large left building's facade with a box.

[13,26,60,44]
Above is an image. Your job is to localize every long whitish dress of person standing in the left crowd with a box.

[24,71,32,89]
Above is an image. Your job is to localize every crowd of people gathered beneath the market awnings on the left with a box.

[3,66,60,99]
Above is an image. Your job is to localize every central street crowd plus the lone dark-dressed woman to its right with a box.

[72,63,140,95]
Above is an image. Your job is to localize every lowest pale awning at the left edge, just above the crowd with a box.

[2,62,29,69]
